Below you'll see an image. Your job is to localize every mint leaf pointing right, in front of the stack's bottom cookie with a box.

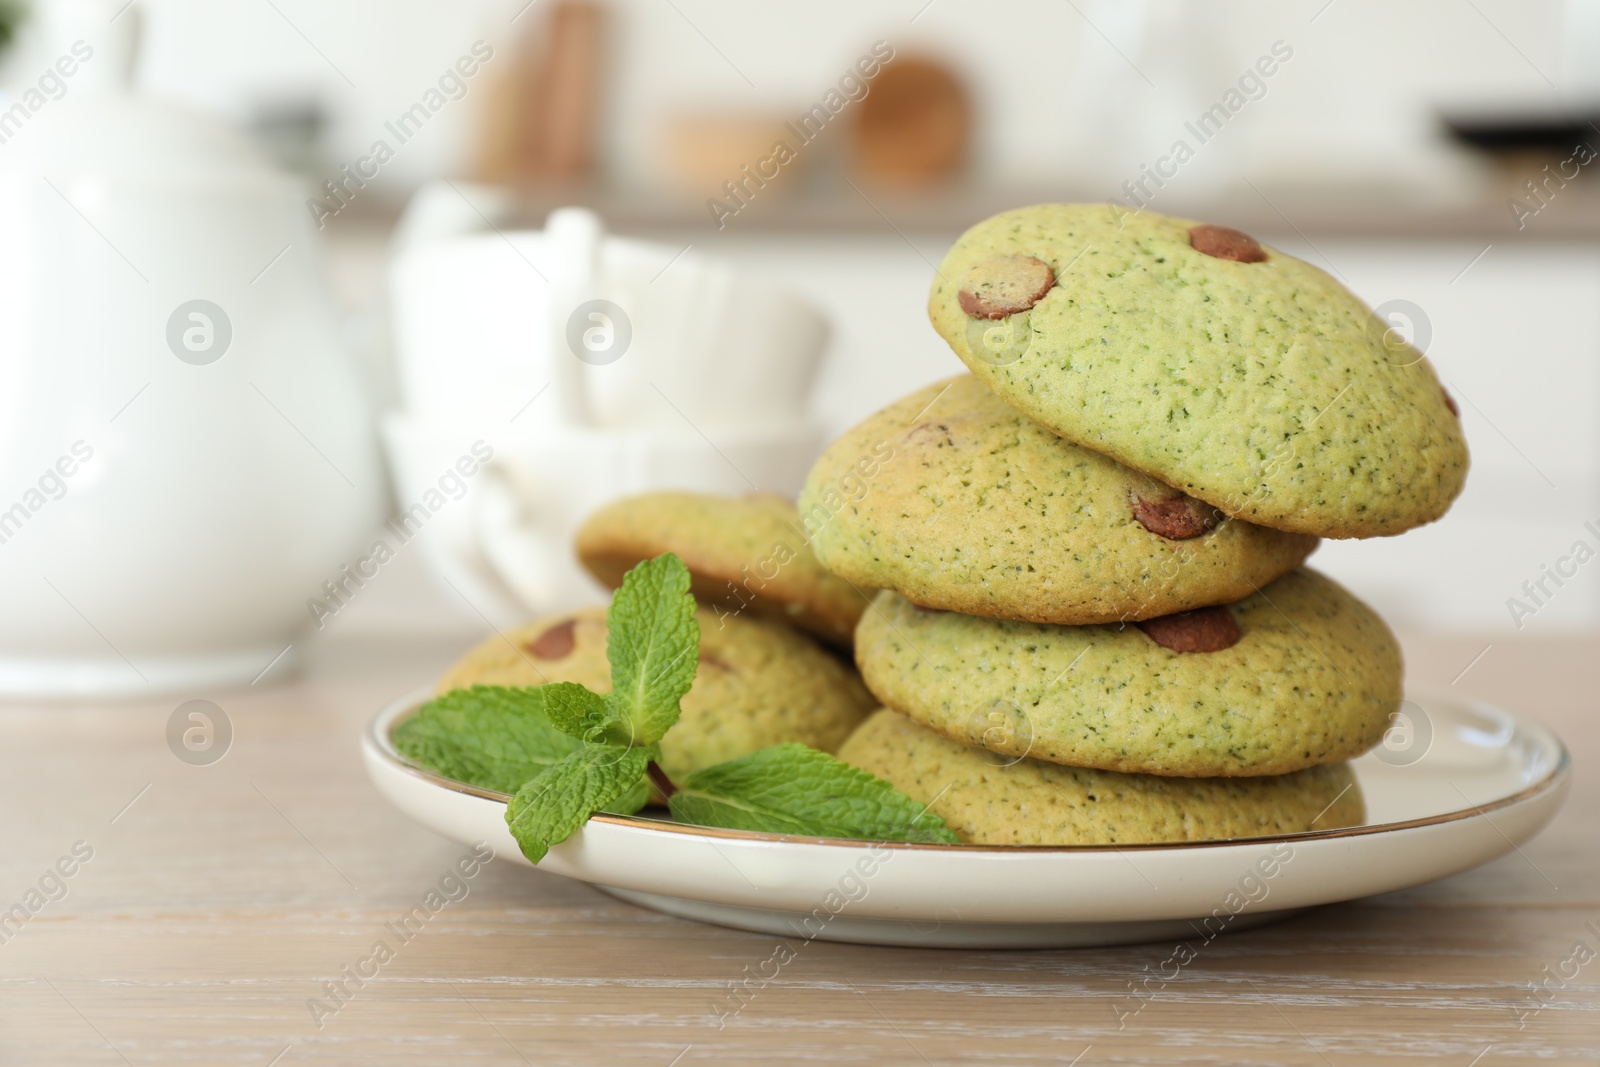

[669,741,960,845]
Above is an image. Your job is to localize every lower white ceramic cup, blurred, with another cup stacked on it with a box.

[382,414,822,627]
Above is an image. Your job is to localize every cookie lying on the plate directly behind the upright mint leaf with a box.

[438,608,877,779]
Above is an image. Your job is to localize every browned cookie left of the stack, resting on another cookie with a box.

[578,493,867,648]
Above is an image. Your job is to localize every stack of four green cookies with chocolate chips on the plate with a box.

[800,205,1467,845]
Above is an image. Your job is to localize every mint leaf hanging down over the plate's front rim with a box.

[506,745,650,862]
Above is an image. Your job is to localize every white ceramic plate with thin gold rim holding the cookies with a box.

[363,694,1570,949]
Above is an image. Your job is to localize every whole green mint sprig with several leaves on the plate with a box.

[395,553,960,862]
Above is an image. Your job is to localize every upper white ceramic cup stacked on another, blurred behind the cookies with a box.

[390,202,827,429]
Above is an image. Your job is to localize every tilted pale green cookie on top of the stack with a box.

[928,203,1467,537]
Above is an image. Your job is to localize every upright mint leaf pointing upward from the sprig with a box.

[605,552,699,744]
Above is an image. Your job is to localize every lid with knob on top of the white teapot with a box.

[0,0,290,182]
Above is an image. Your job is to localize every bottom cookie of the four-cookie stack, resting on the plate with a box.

[838,709,1366,845]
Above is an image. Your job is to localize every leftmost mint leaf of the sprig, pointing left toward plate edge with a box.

[394,685,582,793]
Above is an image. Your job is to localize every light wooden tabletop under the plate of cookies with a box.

[0,638,1600,1067]
